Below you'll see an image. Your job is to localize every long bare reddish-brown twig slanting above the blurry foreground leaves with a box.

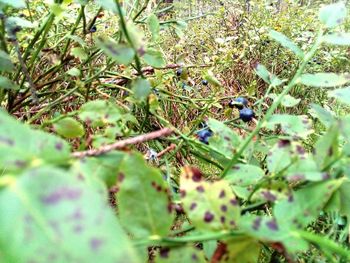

[72,128,173,158]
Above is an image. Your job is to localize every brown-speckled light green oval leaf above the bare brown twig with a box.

[79,100,123,127]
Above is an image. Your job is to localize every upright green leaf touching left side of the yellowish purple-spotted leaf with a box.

[117,154,173,239]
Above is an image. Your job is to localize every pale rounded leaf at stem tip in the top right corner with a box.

[318,2,347,28]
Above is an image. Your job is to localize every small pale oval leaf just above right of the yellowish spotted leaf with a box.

[225,164,264,186]
